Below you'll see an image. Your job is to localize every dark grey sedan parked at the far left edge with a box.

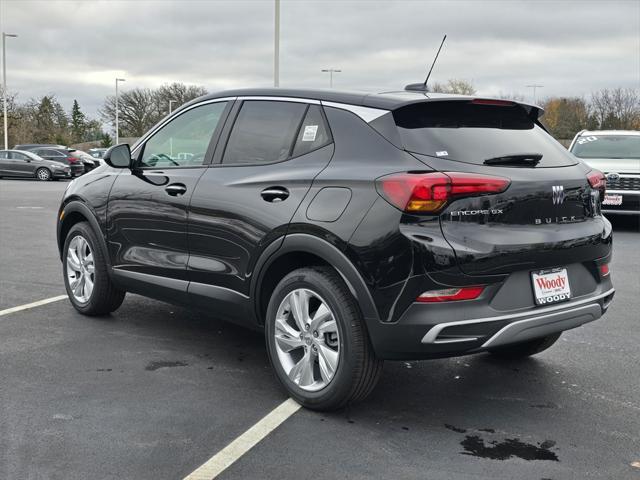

[0,150,71,181]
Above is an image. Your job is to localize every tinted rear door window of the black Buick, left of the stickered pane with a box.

[222,100,307,164]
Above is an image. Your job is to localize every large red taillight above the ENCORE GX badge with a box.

[377,172,511,213]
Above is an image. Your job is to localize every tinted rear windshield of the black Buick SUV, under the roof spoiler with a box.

[393,101,576,167]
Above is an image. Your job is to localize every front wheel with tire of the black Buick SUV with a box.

[62,222,125,315]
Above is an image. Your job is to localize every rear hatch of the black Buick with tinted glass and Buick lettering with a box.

[394,100,610,275]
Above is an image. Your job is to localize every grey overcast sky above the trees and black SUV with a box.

[0,0,640,115]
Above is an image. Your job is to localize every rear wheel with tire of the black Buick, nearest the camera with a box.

[265,267,383,411]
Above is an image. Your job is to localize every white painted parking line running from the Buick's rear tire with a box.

[184,398,300,480]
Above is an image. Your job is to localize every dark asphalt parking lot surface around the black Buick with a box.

[0,180,640,480]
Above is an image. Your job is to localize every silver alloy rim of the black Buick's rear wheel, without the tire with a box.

[274,288,340,392]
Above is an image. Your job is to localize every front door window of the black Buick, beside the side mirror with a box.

[139,102,227,168]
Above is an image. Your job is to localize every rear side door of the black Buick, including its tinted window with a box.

[189,99,333,320]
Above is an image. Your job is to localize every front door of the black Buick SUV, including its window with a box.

[107,101,228,300]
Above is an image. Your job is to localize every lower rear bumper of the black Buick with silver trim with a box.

[369,278,615,360]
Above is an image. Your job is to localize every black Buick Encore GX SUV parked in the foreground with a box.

[57,89,614,409]
